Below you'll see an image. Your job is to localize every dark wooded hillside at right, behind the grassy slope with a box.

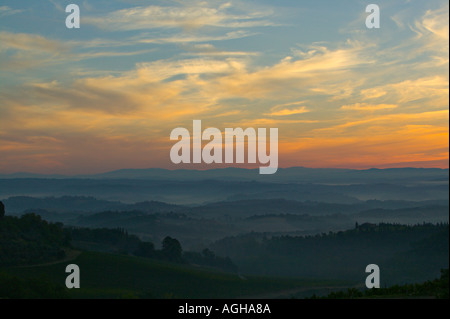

[210,223,449,284]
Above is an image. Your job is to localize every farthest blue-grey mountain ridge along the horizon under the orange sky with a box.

[0,167,449,183]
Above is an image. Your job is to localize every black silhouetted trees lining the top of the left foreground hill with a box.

[0,202,236,271]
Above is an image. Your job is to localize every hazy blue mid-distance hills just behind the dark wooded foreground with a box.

[4,196,449,249]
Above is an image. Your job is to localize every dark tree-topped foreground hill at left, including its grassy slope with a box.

[0,214,340,299]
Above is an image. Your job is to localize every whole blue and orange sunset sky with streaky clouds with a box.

[0,0,449,174]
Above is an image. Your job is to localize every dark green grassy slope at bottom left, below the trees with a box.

[0,252,343,298]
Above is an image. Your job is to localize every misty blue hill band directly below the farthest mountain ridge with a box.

[0,175,449,205]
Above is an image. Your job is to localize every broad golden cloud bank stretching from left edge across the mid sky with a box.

[2,40,376,139]
